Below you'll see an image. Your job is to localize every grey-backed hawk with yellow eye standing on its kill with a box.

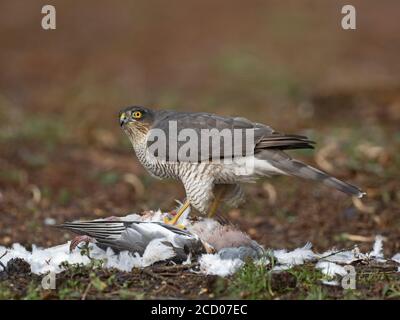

[119,106,364,224]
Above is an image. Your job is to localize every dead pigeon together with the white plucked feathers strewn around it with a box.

[0,211,400,285]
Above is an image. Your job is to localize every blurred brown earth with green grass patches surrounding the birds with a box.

[0,1,400,299]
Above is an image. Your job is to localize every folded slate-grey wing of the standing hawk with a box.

[147,111,314,162]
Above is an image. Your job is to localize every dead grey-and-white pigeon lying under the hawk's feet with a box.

[56,214,264,263]
